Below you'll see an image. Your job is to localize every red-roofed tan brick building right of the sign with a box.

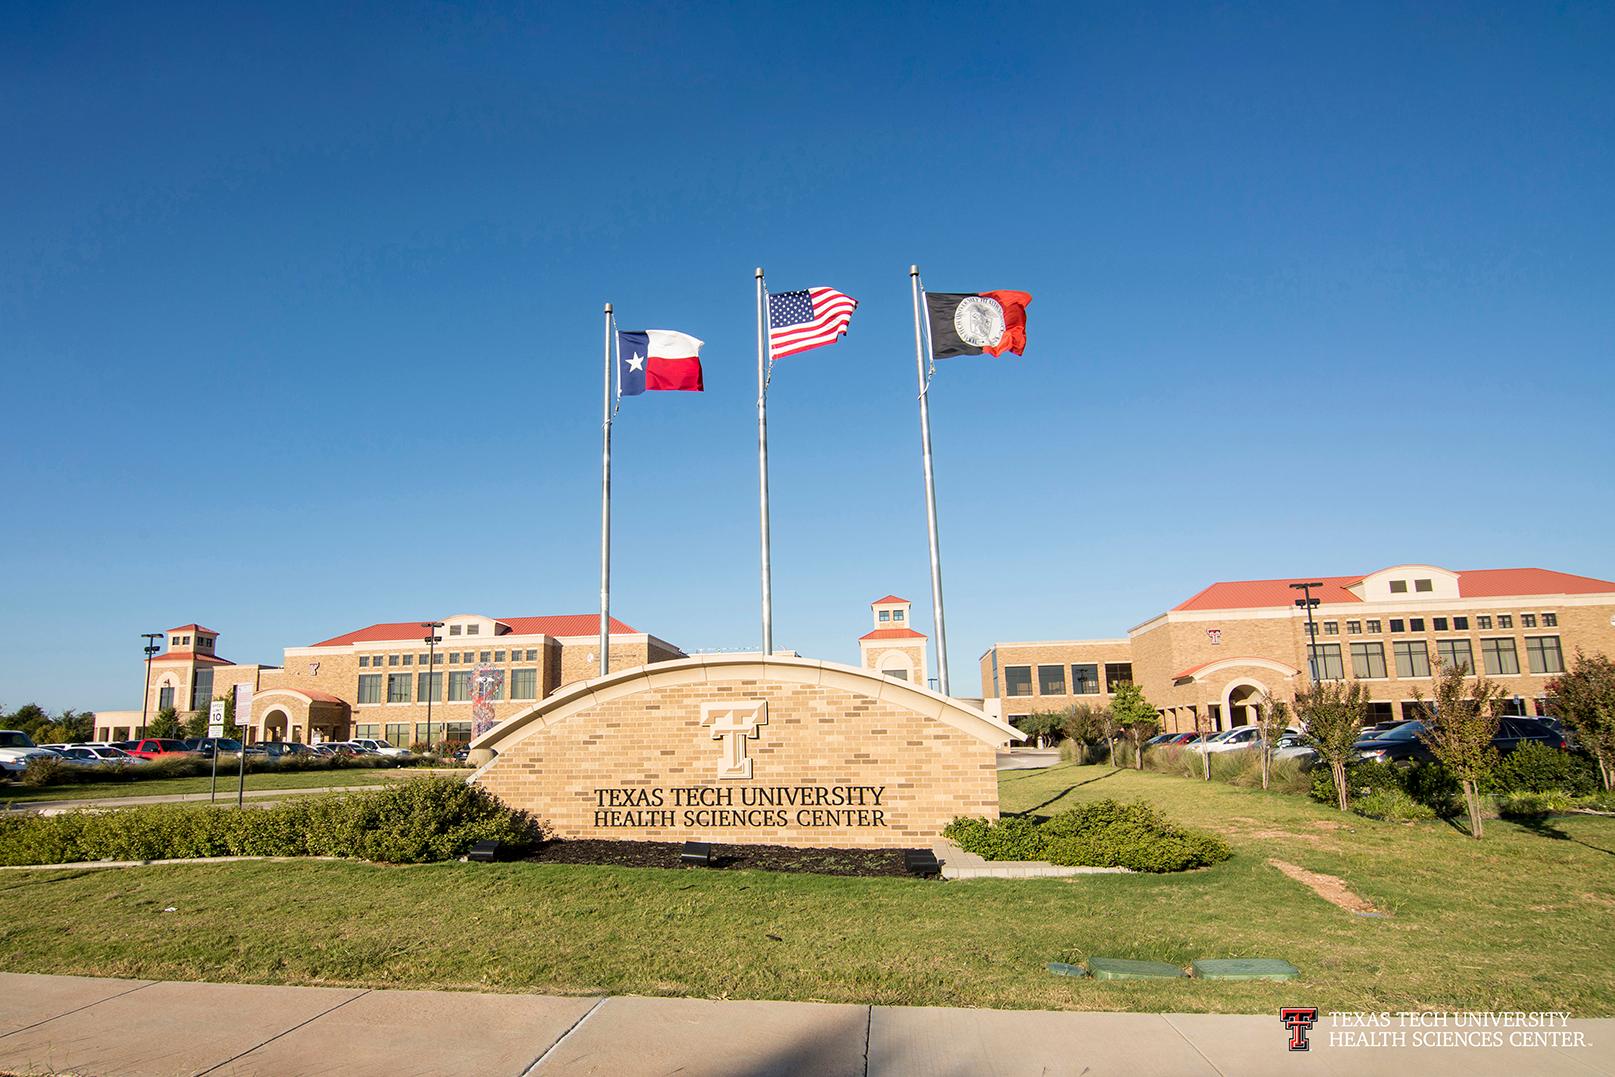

[980,565,1615,730]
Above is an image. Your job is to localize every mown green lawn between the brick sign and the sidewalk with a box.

[0,765,1615,1016]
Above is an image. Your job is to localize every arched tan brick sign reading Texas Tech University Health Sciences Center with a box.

[472,654,1021,848]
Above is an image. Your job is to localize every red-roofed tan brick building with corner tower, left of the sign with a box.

[95,614,683,746]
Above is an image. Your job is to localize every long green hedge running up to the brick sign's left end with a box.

[0,778,543,864]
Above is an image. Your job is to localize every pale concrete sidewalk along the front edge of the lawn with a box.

[0,974,1615,1077]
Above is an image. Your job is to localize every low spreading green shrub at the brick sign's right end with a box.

[943,799,1234,872]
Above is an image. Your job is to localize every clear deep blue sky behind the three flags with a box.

[0,3,1615,709]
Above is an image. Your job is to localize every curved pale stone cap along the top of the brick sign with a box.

[470,652,1026,751]
